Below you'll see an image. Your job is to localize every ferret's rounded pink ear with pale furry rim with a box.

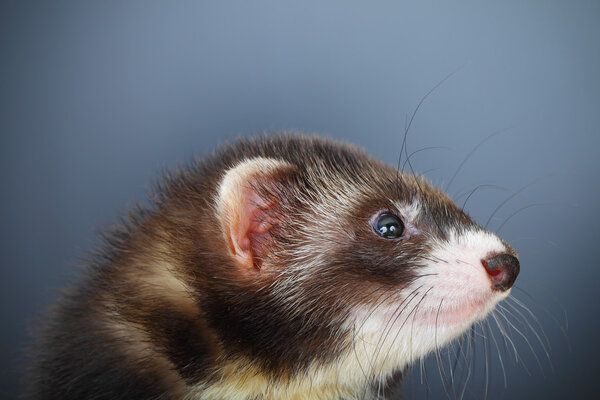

[217,157,295,271]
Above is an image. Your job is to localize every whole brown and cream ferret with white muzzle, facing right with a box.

[25,134,520,400]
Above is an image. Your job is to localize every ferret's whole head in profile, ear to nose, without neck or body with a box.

[207,138,519,392]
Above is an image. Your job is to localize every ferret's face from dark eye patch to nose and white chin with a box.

[332,174,519,371]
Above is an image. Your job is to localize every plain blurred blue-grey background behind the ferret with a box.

[0,0,600,399]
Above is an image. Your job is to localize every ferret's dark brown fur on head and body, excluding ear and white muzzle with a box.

[25,135,482,400]
